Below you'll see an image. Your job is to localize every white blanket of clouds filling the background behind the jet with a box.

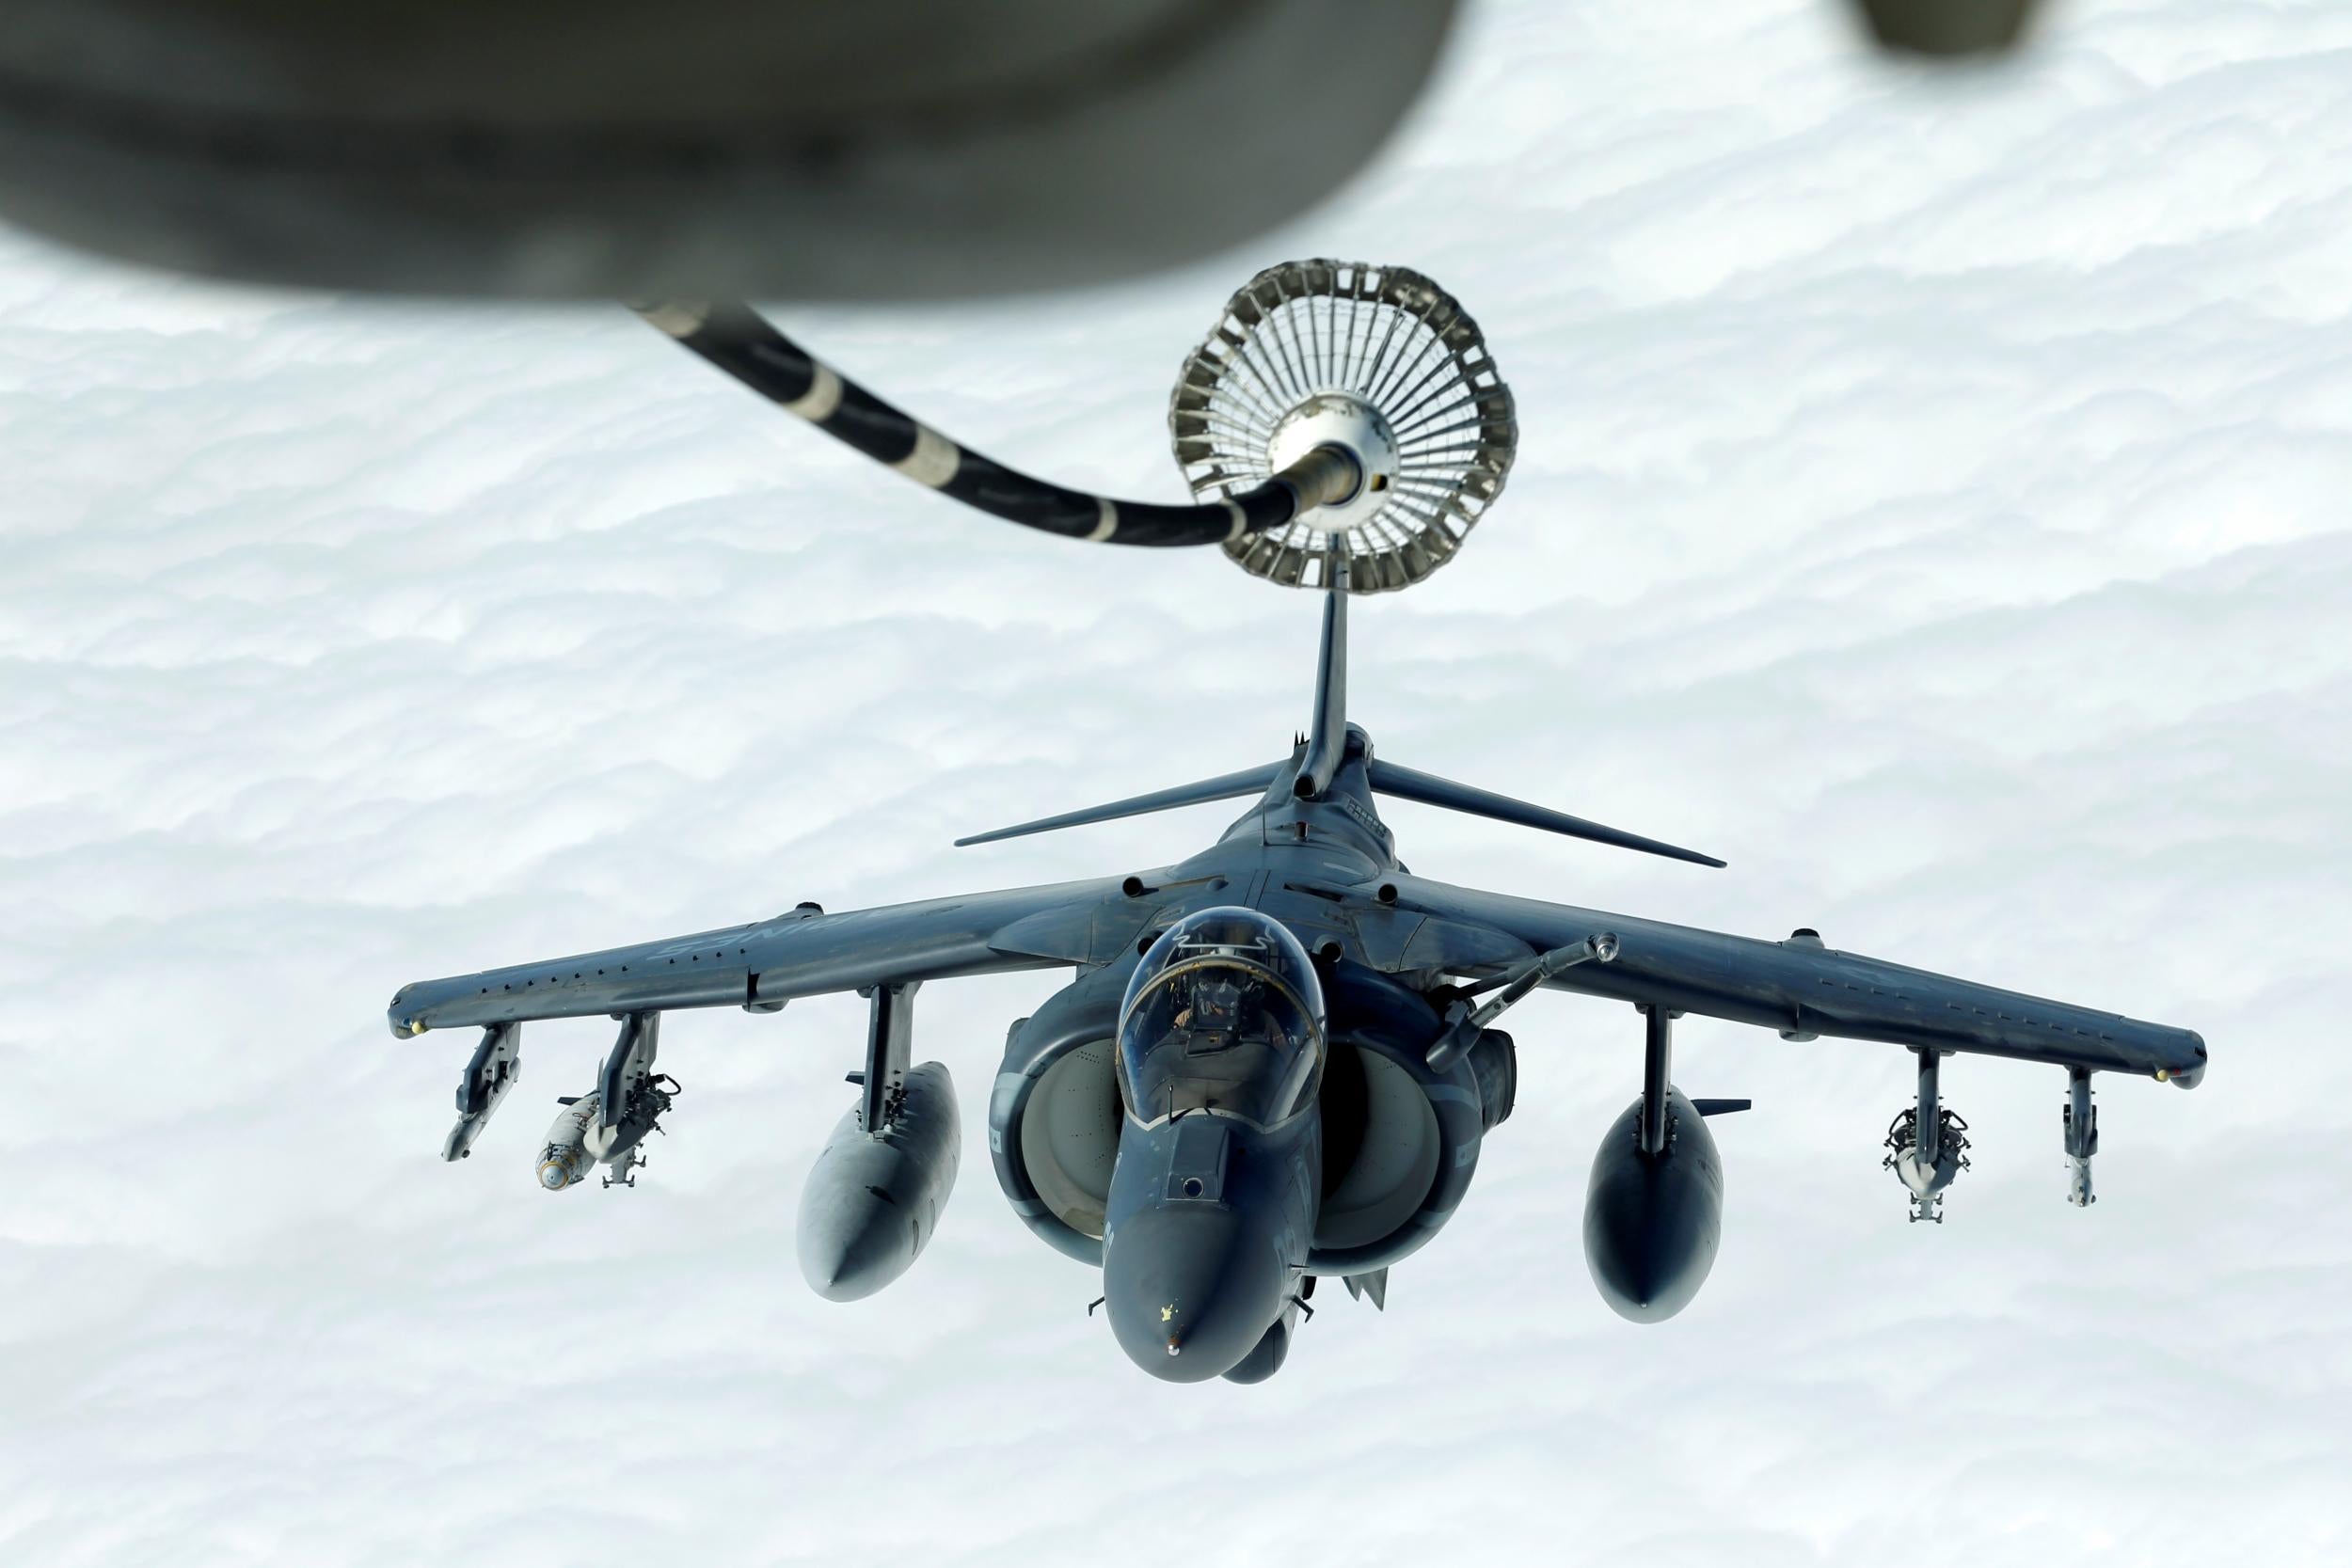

[0,0,2352,1568]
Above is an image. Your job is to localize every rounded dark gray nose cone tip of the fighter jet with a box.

[1104,1204,1284,1383]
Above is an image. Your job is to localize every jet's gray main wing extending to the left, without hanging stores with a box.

[389,877,1151,1037]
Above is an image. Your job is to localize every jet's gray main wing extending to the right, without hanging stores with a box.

[1383,877,2206,1088]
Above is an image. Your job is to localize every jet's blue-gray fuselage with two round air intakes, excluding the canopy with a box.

[991,726,1513,1383]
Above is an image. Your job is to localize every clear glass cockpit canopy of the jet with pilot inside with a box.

[1120,908,1325,1126]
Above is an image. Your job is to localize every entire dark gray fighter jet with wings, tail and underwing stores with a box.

[390,562,2206,1383]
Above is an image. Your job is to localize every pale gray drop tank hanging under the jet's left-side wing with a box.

[795,1063,964,1303]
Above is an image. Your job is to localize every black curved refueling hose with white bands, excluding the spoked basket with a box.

[638,301,1364,546]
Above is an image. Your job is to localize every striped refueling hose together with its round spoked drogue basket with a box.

[638,259,1519,593]
